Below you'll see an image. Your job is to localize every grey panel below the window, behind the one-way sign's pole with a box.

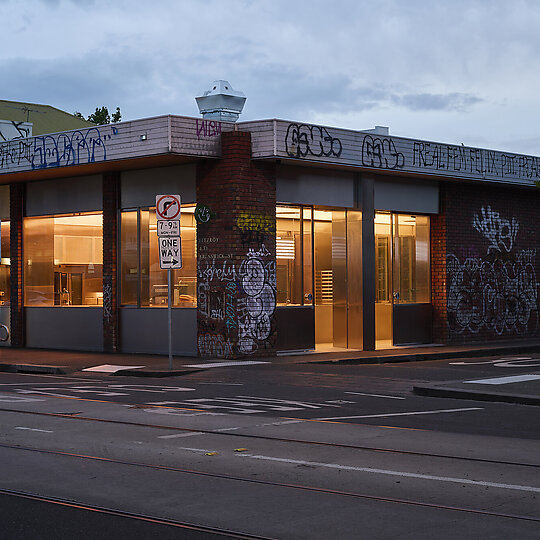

[120,308,197,356]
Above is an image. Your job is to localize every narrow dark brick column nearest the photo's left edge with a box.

[9,183,26,347]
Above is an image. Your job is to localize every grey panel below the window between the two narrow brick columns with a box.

[25,307,103,351]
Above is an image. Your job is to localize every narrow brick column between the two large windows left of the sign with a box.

[103,172,120,353]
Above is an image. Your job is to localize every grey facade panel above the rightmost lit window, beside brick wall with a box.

[375,178,439,214]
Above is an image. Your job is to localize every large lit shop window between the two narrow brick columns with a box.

[23,212,103,306]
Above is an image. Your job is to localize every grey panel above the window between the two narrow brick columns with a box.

[26,174,103,216]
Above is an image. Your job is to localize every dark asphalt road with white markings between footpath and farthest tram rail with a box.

[0,358,540,439]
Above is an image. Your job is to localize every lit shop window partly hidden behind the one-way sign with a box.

[120,205,197,307]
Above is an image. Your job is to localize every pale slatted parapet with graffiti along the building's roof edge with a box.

[0,115,540,186]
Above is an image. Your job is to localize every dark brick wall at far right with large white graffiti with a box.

[440,183,540,343]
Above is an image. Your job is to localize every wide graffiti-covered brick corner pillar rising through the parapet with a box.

[197,132,276,358]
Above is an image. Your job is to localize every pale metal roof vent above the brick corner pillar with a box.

[195,80,247,122]
